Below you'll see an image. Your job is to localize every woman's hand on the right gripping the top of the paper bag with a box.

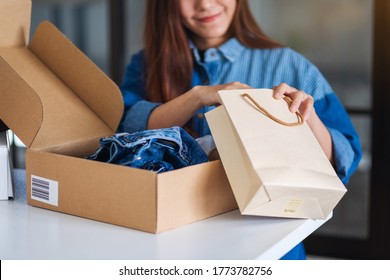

[273,83,314,121]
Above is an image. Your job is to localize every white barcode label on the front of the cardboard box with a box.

[31,175,58,206]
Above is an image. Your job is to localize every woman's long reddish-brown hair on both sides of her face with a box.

[144,0,281,102]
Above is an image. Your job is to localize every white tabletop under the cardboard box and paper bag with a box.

[0,167,330,260]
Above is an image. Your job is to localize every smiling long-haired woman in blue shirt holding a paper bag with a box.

[119,0,361,259]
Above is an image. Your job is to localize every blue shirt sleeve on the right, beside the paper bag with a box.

[302,63,362,184]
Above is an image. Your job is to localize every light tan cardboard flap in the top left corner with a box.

[0,0,31,49]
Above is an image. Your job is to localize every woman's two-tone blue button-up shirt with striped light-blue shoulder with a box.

[119,38,362,186]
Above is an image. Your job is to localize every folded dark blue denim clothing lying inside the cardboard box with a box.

[87,126,208,173]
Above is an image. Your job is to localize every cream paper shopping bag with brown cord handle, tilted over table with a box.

[206,89,346,219]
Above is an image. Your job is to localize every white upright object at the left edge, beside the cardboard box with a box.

[0,131,13,200]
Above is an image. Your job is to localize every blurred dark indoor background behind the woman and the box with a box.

[7,0,390,259]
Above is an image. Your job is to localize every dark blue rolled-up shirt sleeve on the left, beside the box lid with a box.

[118,51,160,133]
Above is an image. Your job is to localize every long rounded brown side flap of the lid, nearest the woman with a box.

[29,21,124,131]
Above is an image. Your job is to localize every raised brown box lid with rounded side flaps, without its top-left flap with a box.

[0,17,123,153]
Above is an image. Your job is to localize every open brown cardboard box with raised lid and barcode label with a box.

[0,0,237,233]
